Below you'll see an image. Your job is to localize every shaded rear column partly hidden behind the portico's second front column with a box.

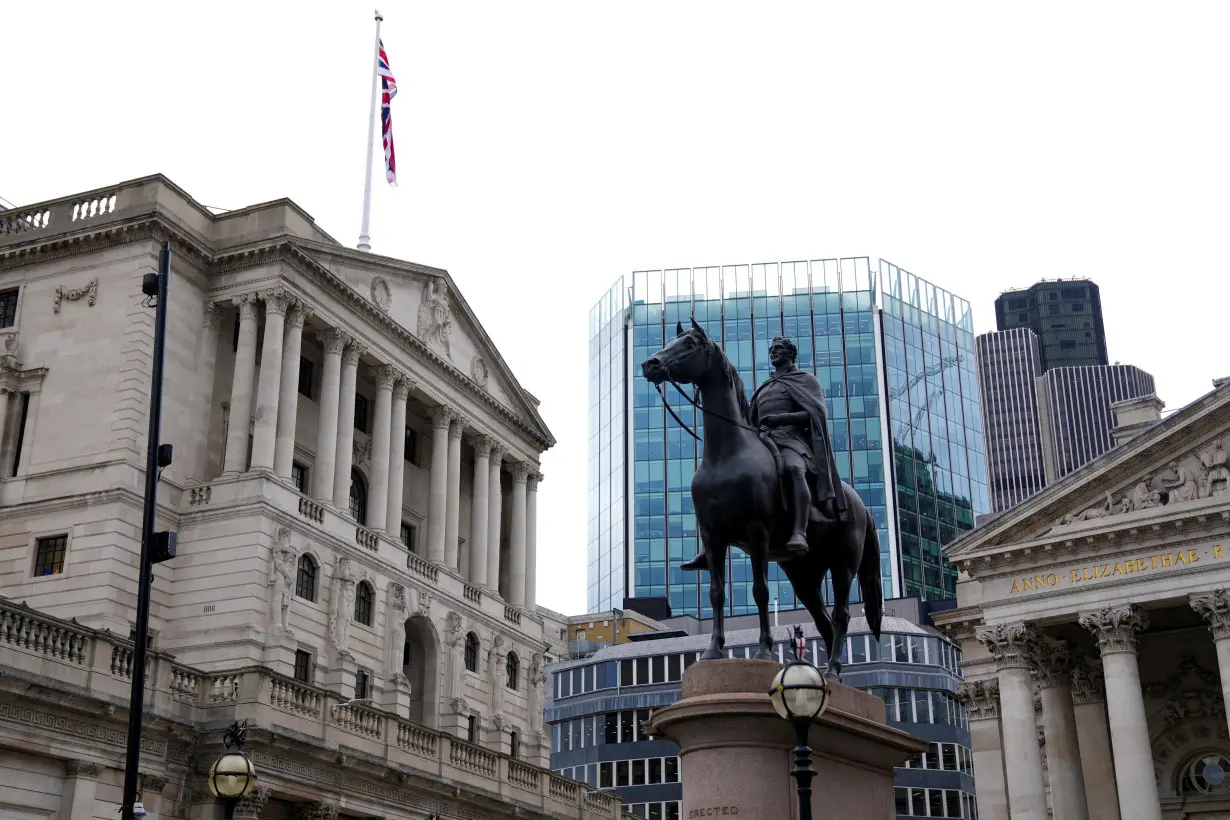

[1071,660,1119,820]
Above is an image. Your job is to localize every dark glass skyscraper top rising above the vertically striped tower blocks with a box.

[995,279,1109,371]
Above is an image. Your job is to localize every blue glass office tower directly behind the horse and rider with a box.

[588,257,988,617]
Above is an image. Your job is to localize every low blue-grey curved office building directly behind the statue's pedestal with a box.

[546,600,978,820]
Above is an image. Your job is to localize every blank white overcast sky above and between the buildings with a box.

[0,0,1230,612]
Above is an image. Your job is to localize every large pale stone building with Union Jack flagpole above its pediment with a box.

[0,176,620,820]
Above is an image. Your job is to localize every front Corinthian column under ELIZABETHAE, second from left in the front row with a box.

[1080,604,1161,820]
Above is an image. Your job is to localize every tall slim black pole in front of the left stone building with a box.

[119,241,171,820]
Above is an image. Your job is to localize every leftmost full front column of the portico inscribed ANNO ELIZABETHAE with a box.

[978,623,1048,820]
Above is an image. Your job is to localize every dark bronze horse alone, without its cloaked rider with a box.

[641,318,884,677]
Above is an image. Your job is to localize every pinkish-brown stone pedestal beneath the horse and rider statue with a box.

[649,659,926,820]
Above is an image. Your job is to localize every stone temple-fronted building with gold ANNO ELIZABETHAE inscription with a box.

[935,380,1230,820]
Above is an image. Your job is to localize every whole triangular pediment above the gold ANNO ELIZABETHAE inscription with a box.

[946,385,1230,562]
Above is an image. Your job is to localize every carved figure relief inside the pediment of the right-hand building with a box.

[1059,436,1230,525]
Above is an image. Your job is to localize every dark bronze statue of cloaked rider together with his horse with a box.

[641,318,883,677]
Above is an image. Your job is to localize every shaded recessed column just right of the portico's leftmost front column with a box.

[1033,644,1089,820]
